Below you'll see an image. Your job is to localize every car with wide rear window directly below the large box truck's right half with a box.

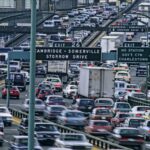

[94,98,114,108]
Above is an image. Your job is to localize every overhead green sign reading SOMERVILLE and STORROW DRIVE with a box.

[36,47,101,61]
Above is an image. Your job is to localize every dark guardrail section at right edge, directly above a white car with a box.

[128,96,150,106]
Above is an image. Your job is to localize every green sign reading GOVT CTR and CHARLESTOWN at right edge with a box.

[117,47,150,63]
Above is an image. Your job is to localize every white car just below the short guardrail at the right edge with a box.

[131,106,150,117]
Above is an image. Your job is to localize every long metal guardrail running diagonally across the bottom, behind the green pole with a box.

[9,108,132,150]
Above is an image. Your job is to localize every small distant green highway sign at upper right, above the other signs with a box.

[108,25,146,32]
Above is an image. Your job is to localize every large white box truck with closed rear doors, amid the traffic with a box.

[78,67,114,98]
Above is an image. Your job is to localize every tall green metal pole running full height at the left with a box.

[28,0,36,150]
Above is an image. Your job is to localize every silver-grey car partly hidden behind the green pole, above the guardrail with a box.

[22,99,46,114]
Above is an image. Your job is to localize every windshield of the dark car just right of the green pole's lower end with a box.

[35,124,56,131]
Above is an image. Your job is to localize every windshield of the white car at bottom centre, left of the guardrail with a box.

[61,134,84,142]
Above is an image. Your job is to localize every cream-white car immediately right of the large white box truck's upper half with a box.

[115,71,131,83]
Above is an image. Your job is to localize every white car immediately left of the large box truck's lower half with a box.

[63,85,78,98]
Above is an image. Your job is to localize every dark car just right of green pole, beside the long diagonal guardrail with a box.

[34,122,60,146]
